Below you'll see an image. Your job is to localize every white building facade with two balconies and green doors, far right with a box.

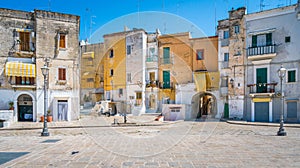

[244,3,300,122]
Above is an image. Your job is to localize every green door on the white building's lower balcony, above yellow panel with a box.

[256,68,267,93]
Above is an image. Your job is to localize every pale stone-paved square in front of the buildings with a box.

[0,117,300,167]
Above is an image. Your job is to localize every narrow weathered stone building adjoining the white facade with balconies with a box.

[218,8,246,119]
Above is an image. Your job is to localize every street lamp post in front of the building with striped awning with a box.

[41,63,49,136]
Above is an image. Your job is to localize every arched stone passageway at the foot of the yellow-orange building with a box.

[191,92,218,120]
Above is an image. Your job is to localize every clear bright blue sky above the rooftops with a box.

[0,0,297,42]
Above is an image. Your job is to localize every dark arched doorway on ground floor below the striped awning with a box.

[18,94,33,121]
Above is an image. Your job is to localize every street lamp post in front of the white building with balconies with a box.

[277,65,286,136]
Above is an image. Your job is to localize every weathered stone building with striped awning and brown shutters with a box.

[0,9,80,122]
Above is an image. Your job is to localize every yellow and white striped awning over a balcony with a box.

[5,62,35,77]
